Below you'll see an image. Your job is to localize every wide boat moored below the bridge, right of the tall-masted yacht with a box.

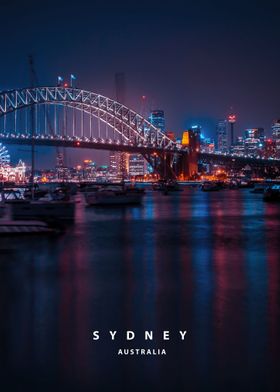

[85,186,144,206]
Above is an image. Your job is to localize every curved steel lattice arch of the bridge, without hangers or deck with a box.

[0,87,177,150]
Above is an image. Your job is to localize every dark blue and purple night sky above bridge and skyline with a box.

[0,0,280,165]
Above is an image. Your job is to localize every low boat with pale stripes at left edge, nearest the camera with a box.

[0,220,55,235]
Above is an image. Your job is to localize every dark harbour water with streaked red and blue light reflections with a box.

[0,189,280,392]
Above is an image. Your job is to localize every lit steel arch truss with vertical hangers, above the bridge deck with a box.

[0,87,177,150]
